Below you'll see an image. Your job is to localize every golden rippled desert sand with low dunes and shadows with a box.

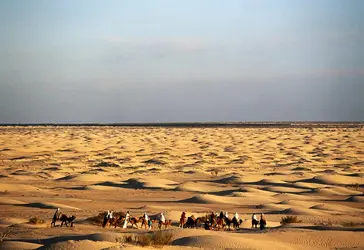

[0,126,364,249]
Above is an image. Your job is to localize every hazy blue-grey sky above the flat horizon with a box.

[0,0,364,123]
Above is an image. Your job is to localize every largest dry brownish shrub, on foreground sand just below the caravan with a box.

[124,231,174,247]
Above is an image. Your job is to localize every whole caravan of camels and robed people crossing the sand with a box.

[51,208,267,231]
